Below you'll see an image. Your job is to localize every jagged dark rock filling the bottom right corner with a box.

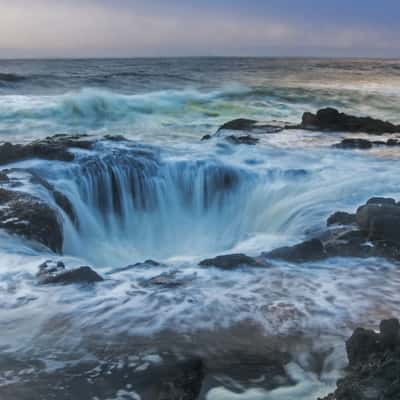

[325,319,400,400]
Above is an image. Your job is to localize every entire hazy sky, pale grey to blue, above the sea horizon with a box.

[0,0,400,58]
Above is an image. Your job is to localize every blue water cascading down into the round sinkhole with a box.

[40,144,310,265]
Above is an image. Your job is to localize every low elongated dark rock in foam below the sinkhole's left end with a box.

[40,266,104,285]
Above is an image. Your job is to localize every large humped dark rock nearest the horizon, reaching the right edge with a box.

[300,108,400,134]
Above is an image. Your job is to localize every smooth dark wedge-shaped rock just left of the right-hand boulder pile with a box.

[262,239,327,263]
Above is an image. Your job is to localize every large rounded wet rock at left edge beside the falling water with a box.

[0,188,63,253]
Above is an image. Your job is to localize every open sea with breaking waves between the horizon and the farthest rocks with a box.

[0,58,400,141]
